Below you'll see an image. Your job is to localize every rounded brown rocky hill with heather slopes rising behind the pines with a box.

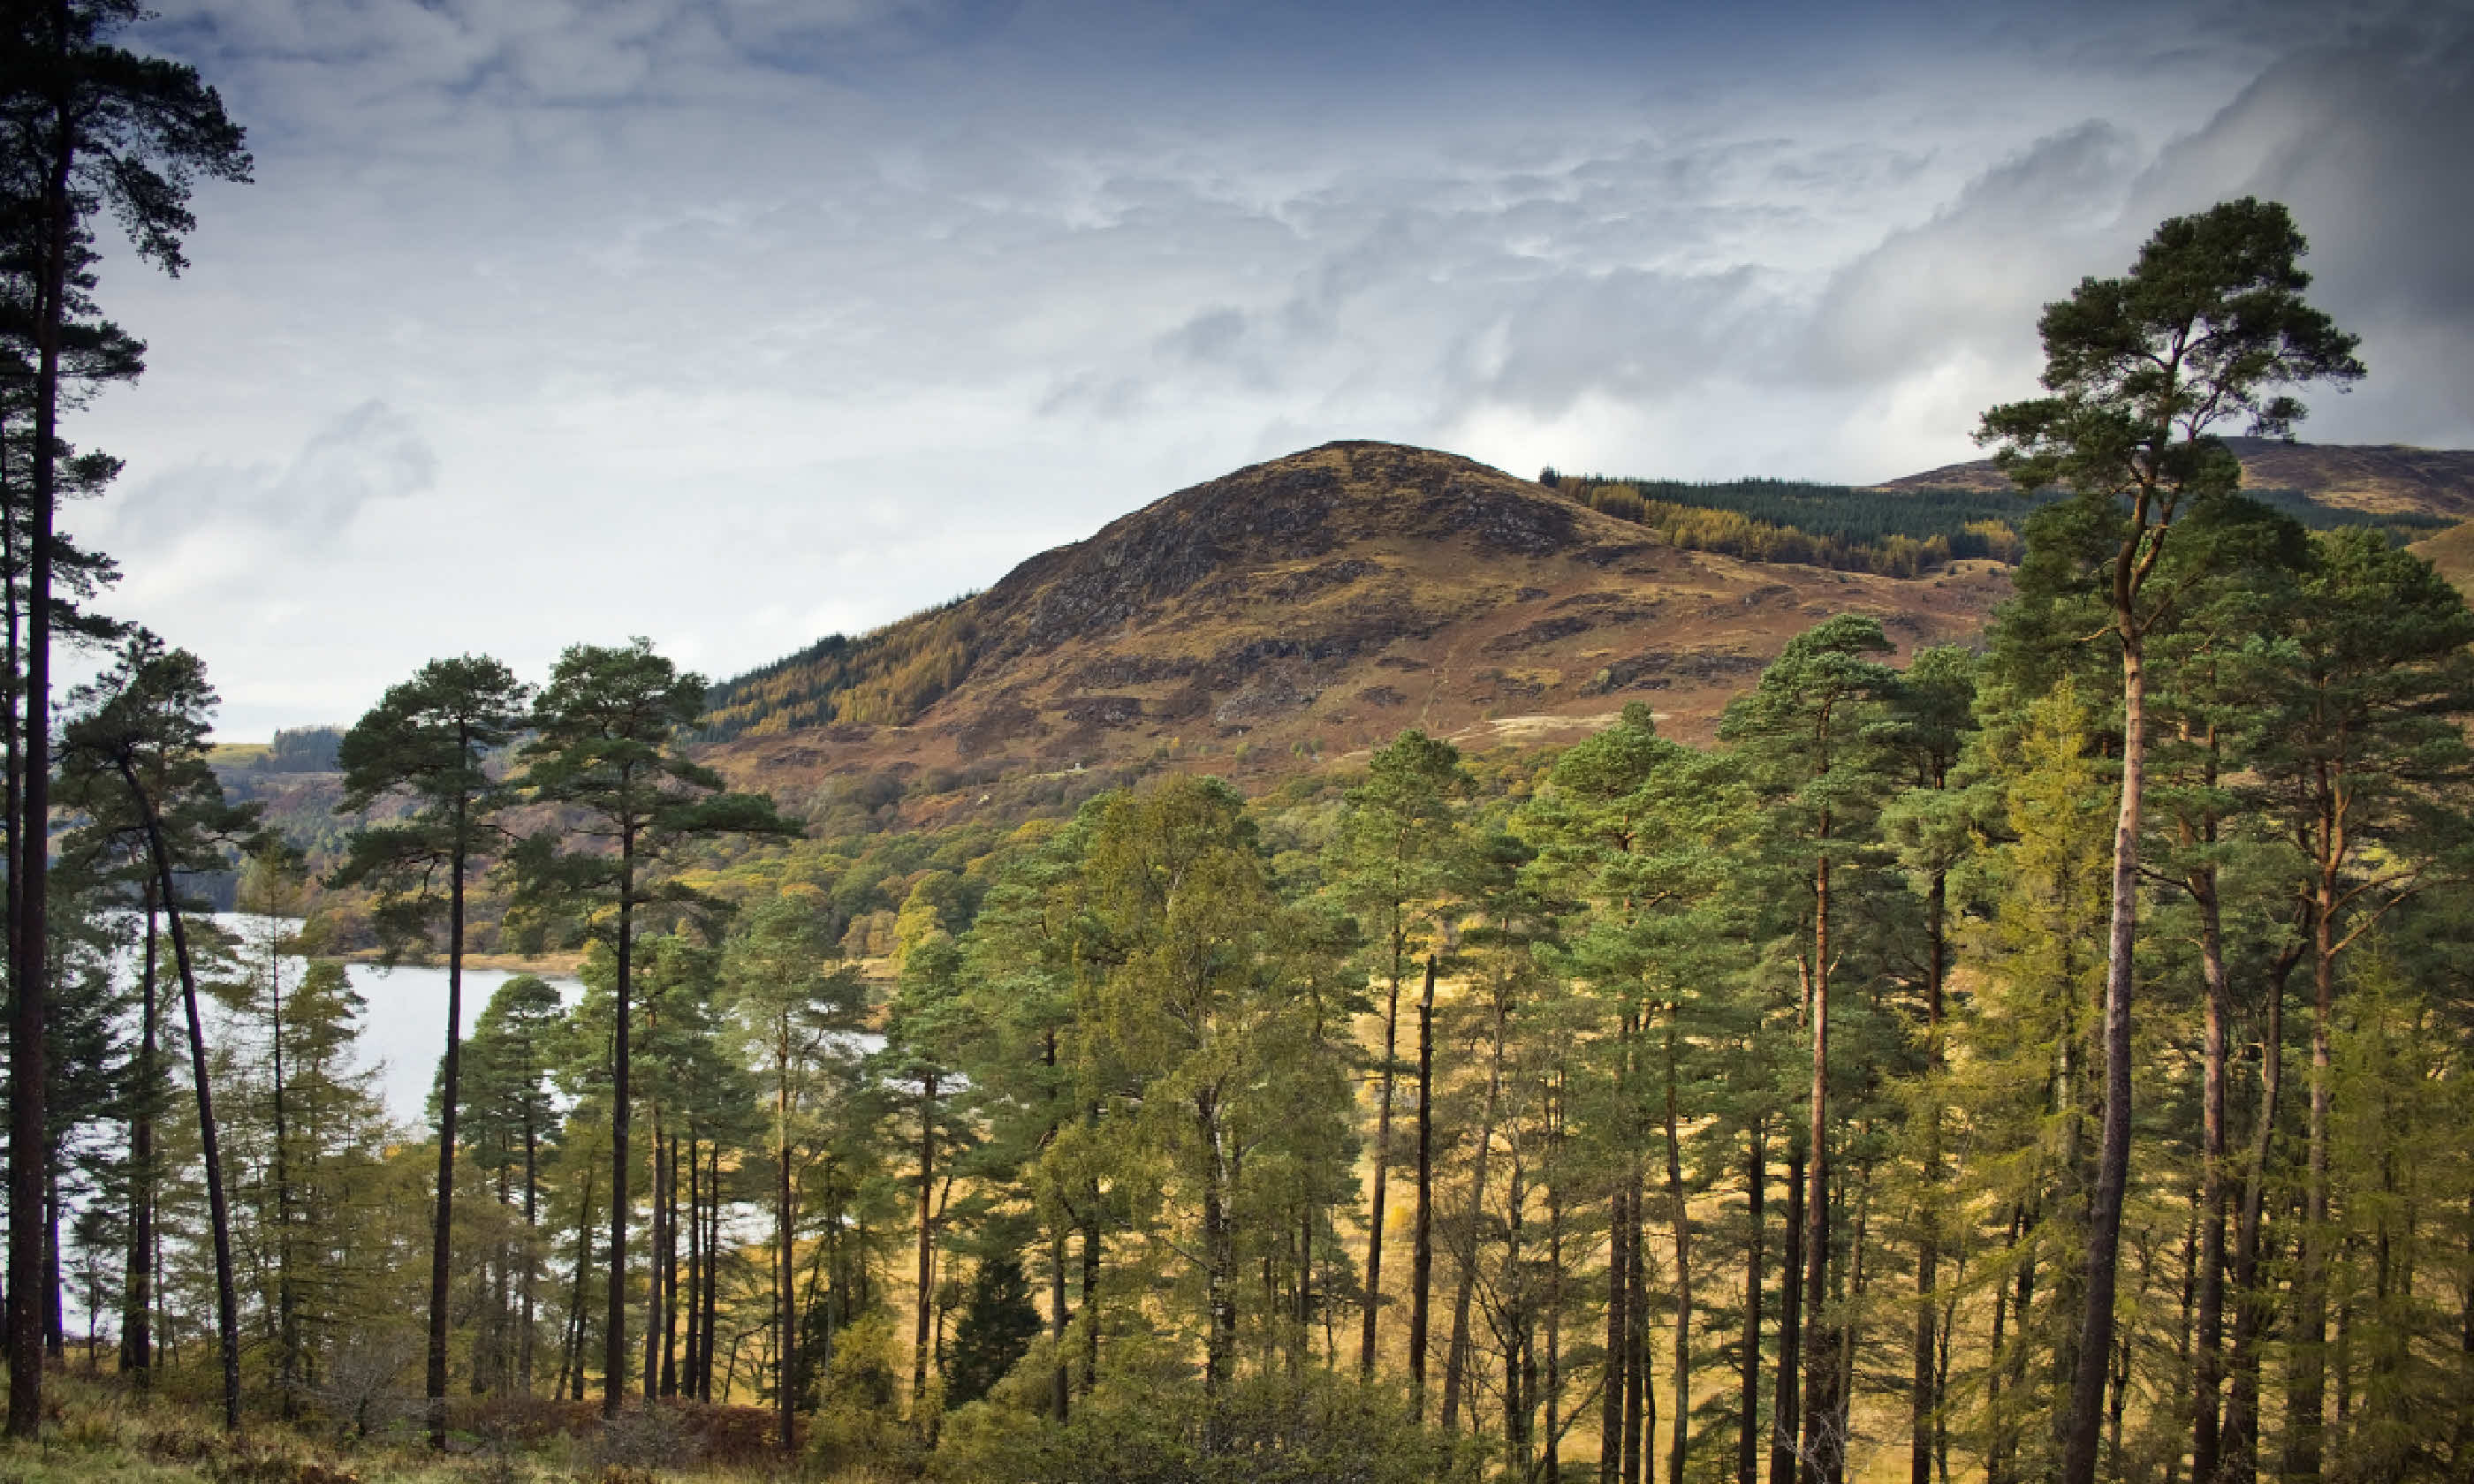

[708,443,2009,816]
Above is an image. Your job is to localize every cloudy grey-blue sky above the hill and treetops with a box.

[65,0,2474,739]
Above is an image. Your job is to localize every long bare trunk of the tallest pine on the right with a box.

[2060,623,2147,1484]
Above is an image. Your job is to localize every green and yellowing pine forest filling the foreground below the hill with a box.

[0,0,2474,1484]
